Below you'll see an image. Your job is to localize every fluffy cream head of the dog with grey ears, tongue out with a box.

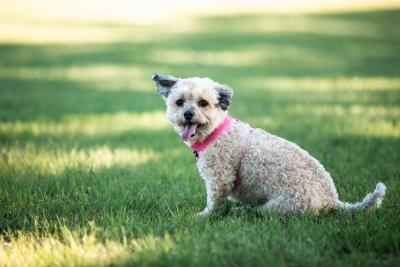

[152,74,233,143]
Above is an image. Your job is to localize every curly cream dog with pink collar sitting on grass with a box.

[152,74,386,215]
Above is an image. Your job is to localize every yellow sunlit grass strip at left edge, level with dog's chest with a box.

[0,144,159,179]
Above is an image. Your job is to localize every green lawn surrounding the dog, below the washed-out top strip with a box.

[0,10,400,266]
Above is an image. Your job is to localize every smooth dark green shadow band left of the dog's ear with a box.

[0,80,164,121]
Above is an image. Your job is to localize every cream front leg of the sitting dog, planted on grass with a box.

[197,177,234,216]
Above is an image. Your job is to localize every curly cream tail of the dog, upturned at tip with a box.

[339,182,386,211]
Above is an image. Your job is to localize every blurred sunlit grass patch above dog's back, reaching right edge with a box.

[249,104,400,138]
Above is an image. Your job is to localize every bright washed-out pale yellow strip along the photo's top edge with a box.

[0,0,400,43]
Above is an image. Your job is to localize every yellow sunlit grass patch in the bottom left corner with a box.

[0,226,174,266]
